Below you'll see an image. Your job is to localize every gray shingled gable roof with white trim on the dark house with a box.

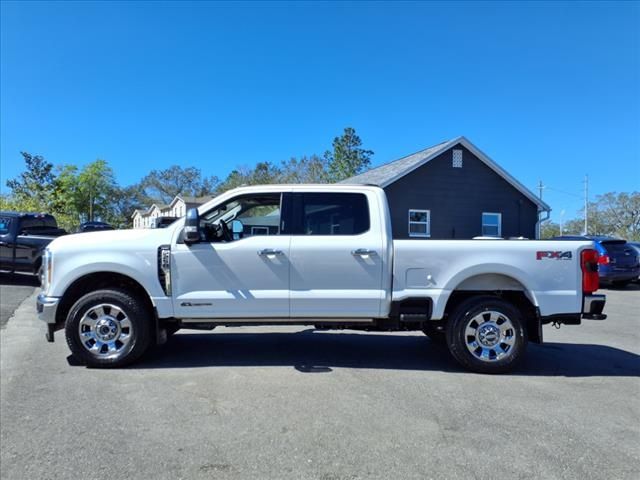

[340,137,551,211]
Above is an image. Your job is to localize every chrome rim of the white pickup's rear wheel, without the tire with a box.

[464,310,516,362]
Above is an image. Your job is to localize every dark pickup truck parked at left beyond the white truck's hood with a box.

[0,212,67,275]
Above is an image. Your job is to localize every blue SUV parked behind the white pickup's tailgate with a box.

[551,235,640,287]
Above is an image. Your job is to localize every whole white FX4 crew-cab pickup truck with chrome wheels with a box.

[37,185,606,373]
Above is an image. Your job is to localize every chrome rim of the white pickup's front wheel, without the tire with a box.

[78,303,134,358]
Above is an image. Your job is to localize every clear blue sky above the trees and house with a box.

[0,2,640,218]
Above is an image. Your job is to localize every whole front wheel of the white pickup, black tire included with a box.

[65,290,152,368]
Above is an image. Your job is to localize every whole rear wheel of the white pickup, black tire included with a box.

[447,296,527,373]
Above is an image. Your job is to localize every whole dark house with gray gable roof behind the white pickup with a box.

[342,137,551,239]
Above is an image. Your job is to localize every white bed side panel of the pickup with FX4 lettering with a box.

[392,240,593,320]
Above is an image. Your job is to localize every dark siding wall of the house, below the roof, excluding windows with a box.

[385,145,538,239]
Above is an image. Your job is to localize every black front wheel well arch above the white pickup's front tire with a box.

[56,272,154,326]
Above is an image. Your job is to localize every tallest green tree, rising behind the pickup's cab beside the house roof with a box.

[324,127,373,182]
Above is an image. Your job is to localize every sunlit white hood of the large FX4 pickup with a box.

[48,228,174,253]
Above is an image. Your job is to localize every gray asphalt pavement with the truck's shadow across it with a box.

[0,287,640,480]
